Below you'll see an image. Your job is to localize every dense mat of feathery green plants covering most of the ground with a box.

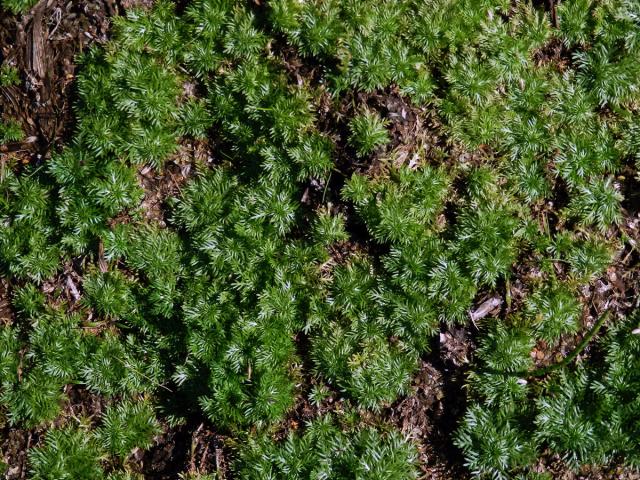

[0,0,640,479]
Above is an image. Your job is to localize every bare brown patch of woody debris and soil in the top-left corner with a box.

[0,0,118,161]
